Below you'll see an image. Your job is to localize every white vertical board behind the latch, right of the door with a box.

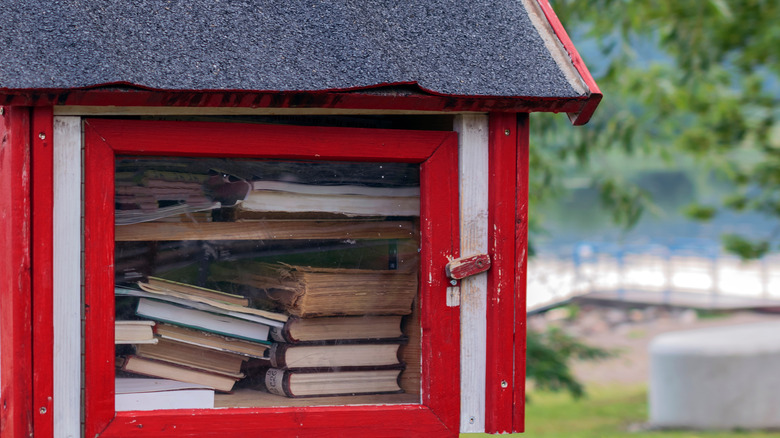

[454,115,488,433]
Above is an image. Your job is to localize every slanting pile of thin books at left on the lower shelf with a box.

[115,277,287,392]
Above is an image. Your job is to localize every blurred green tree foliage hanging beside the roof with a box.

[530,0,780,257]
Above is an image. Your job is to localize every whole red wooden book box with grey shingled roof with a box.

[0,0,601,438]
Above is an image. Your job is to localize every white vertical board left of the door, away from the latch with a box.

[52,117,82,437]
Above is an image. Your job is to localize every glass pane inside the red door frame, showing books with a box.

[115,157,420,409]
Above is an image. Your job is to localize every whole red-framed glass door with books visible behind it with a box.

[84,119,459,436]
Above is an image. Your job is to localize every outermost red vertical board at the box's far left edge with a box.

[0,107,33,438]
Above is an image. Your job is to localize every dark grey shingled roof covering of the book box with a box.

[0,0,593,118]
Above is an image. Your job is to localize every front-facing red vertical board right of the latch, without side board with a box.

[485,113,522,433]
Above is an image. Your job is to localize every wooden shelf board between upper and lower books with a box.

[115,220,415,242]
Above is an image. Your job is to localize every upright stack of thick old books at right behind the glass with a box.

[212,263,417,397]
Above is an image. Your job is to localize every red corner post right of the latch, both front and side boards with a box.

[485,113,528,433]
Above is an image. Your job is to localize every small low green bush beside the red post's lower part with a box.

[526,327,615,398]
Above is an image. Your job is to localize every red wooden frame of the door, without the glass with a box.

[85,119,460,437]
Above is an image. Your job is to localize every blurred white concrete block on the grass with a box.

[649,322,780,429]
